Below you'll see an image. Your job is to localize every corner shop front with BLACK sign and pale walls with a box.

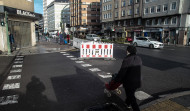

[0,6,42,51]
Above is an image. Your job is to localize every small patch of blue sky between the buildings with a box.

[34,0,43,14]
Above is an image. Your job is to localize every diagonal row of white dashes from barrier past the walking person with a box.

[60,52,152,100]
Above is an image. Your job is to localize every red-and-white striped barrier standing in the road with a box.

[80,42,113,58]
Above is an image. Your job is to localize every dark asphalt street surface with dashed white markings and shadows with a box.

[0,39,190,111]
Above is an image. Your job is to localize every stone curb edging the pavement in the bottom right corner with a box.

[140,91,190,110]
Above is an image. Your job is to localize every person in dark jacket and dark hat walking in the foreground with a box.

[115,46,142,111]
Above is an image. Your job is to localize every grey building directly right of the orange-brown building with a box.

[102,0,143,37]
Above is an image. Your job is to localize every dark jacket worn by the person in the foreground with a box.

[115,54,142,88]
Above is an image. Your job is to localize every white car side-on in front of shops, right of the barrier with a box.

[133,37,164,48]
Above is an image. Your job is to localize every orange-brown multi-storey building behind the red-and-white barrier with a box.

[70,0,101,35]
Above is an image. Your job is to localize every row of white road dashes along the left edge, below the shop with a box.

[0,55,24,106]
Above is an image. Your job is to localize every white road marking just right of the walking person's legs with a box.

[135,91,152,100]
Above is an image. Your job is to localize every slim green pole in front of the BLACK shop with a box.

[5,11,11,55]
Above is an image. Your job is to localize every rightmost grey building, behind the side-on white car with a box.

[143,0,190,45]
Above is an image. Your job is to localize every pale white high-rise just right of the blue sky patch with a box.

[47,0,69,32]
